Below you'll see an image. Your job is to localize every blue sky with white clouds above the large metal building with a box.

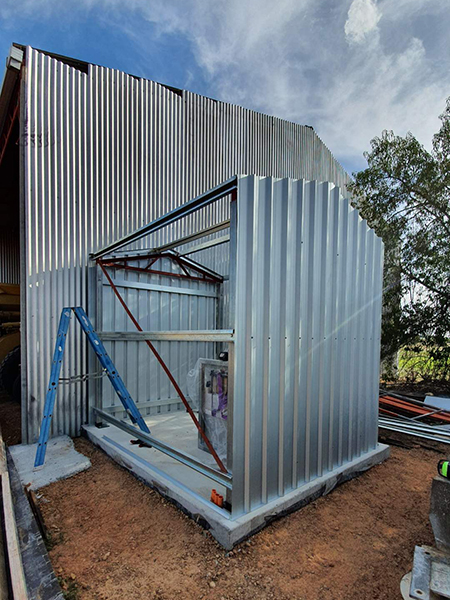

[0,0,450,172]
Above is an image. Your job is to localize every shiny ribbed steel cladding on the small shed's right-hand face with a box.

[233,176,383,516]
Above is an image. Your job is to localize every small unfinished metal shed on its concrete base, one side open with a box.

[79,175,386,547]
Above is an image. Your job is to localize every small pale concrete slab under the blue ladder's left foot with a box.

[9,435,91,490]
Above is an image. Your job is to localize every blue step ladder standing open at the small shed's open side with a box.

[34,306,150,468]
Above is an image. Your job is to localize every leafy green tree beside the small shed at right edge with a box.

[349,98,450,377]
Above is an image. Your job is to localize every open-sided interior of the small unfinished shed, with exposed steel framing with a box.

[88,178,237,516]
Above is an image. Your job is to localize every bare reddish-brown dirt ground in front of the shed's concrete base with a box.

[35,439,442,600]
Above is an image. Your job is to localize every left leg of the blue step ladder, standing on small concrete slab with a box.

[34,308,71,467]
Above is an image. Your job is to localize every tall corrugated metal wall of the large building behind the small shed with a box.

[20,47,349,442]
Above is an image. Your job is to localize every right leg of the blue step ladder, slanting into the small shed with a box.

[72,306,150,433]
